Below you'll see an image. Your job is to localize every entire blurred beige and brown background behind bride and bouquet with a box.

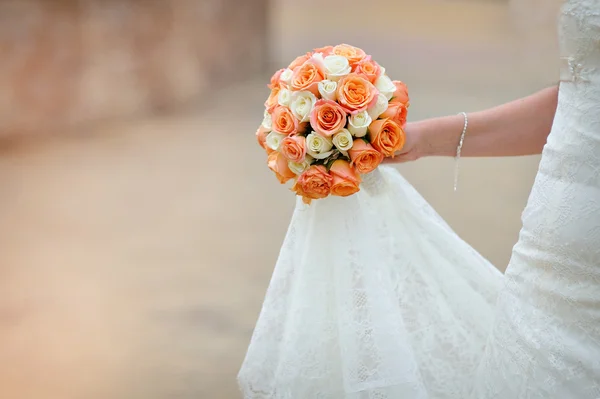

[0,0,555,399]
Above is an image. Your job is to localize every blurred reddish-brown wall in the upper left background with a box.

[0,0,267,140]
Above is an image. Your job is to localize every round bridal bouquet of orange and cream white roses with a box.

[256,44,409,204]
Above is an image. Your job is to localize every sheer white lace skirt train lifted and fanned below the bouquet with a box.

[238,167,502,399]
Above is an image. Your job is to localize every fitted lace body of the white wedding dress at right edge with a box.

[473,0,600,399]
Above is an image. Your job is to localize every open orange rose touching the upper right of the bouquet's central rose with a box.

[336,73,379,114]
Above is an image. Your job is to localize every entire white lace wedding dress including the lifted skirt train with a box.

[238,0,600,399]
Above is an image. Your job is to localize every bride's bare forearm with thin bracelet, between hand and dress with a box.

[409,87,558,157]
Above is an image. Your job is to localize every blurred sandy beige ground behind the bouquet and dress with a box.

[0,0,549,399]
